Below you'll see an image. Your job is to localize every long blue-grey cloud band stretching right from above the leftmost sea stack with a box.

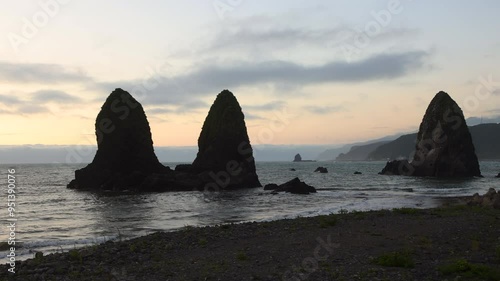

[97,51,430,105]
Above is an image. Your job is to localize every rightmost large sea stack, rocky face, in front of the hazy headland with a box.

[382,91,481,177]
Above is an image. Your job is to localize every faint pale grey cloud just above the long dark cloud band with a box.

[204,19,419,55]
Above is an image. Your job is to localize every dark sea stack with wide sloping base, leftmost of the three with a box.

[68,89,168,191]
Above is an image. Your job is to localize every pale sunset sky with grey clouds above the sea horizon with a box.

[0,0,500,149]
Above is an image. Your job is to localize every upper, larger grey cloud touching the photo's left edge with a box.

[0,61,92,84]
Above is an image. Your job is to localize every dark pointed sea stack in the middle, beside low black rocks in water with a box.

[192,90,261,189]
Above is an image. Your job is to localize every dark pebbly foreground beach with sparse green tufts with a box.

[0,200,500,281]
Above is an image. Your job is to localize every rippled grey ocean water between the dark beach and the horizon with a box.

[0,161,500,263]
